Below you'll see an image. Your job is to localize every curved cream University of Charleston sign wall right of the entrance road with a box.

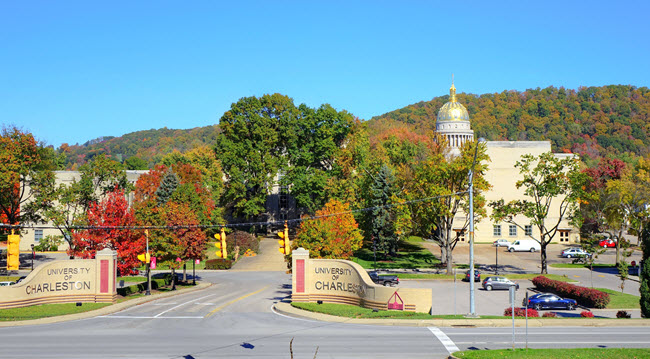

[291,248,432,313]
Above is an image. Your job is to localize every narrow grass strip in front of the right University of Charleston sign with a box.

[291,303,507,319]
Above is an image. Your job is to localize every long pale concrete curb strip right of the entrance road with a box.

[273,302,650,328]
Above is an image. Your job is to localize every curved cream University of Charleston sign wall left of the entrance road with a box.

[0,249,117,309]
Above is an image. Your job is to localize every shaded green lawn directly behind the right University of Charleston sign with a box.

[351,237,440,269]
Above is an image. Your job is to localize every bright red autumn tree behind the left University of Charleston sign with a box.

[68,189,145,275]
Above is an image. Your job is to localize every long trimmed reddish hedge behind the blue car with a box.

[532,276,610,309]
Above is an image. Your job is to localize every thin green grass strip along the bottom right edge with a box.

[454,348,650,359]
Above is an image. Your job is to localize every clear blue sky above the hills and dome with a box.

[0,0,650,147]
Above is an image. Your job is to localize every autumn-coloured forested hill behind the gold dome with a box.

[369,85,650,165]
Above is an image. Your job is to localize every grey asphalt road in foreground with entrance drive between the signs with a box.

[0,271,650,359]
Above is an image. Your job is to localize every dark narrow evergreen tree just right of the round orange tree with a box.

[370,164,398,256]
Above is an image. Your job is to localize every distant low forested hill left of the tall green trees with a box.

[59,125,219,169]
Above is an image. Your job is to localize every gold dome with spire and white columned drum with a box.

[436,81,474,155]
